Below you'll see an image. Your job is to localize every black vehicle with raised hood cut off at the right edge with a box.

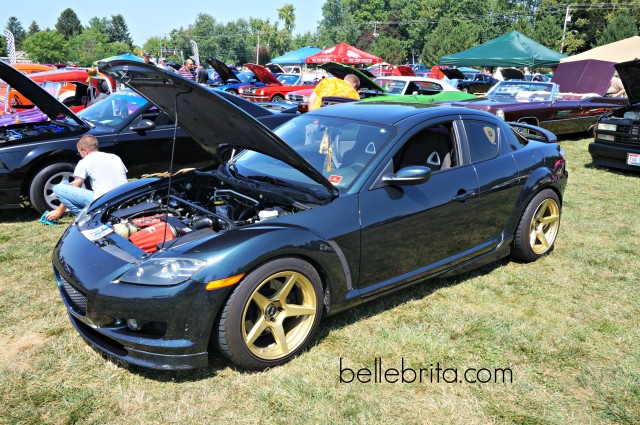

[589,59,640,173]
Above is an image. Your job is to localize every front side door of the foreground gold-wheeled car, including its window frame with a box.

[359,118,478,296]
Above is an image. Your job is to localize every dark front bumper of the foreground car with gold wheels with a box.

[53,226,227,369]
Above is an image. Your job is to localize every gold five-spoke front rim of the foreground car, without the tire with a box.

[242,271,317,360]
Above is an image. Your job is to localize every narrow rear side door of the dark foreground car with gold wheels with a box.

[462,116,521,255]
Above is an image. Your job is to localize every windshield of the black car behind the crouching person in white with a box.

[78,90,148,127]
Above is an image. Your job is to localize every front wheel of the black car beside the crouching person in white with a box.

[29,162,75,214]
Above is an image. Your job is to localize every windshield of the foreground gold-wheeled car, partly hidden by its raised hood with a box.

[235,114,394,193]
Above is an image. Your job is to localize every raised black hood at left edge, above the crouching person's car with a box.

[0,61,88,127]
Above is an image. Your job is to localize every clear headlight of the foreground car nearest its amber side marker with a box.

[115,258,207,286]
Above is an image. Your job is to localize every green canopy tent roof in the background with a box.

[438,31,565,68]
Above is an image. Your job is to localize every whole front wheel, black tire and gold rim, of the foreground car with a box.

[217,258,323,370]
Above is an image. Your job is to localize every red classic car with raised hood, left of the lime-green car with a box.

[238,63,315,102]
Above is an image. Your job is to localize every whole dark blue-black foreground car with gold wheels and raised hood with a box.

[52,62,567,370]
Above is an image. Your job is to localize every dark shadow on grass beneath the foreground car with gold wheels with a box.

[120,258,510,383]
